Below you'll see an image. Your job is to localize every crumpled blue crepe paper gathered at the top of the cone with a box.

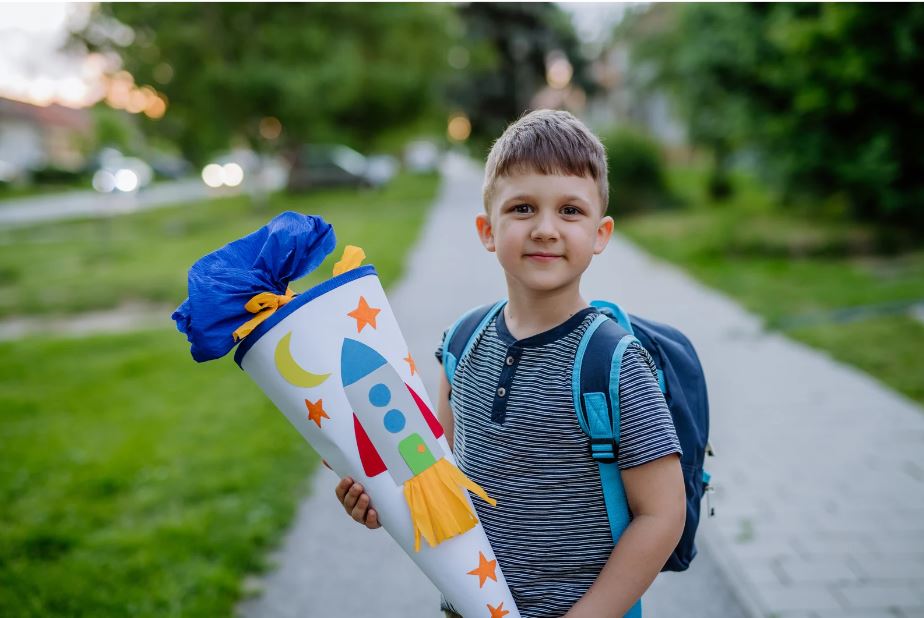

[172,212,337,363]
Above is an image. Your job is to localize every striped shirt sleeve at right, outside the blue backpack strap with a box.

[618,344,682,470]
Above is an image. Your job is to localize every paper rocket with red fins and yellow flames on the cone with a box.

[340,338,496,551]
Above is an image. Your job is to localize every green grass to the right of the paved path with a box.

[616,170,924,403]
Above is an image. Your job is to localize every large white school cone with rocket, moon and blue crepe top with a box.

[174,213,519,618]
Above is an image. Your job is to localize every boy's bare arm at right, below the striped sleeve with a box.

[565,453,686,618]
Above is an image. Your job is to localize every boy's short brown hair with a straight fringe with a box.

[482,109,609,216]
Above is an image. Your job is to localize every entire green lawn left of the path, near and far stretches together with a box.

[0,171,437,618]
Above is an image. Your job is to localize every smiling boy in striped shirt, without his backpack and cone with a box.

[336,110,686,618]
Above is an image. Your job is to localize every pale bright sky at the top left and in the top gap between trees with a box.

[0,2,626,107]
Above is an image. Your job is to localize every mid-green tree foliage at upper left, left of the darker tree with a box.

[73,3,455,162]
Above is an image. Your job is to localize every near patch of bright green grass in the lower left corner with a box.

[0,331,316,617]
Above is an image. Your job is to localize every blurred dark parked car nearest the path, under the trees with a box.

[287,144,399,191]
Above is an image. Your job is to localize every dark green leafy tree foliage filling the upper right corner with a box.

[621,3,924,233]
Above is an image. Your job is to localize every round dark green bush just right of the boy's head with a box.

[600,128,674,214]
